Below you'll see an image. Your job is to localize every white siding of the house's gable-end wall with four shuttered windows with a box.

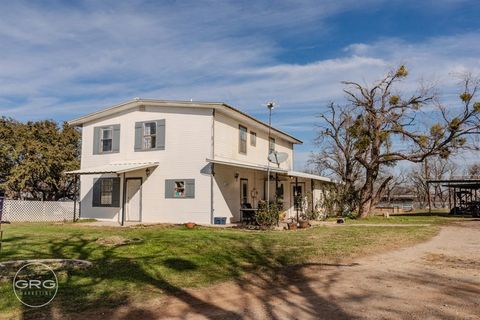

[81,106,213,223]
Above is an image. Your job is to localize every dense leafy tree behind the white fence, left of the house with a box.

[0,119,80,200]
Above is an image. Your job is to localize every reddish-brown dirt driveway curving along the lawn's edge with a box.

[92,221,480,320]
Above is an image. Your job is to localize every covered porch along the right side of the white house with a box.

[208,160,333,223]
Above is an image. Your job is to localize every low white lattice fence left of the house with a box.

[2,200,74,222]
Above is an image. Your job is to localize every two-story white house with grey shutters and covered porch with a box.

[69,99,330,224]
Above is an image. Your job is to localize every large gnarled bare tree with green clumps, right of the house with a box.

[321,66,480,217]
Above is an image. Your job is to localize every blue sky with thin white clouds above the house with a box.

[0,0,480,169]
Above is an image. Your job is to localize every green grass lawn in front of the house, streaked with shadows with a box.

[0,216,456,316]
